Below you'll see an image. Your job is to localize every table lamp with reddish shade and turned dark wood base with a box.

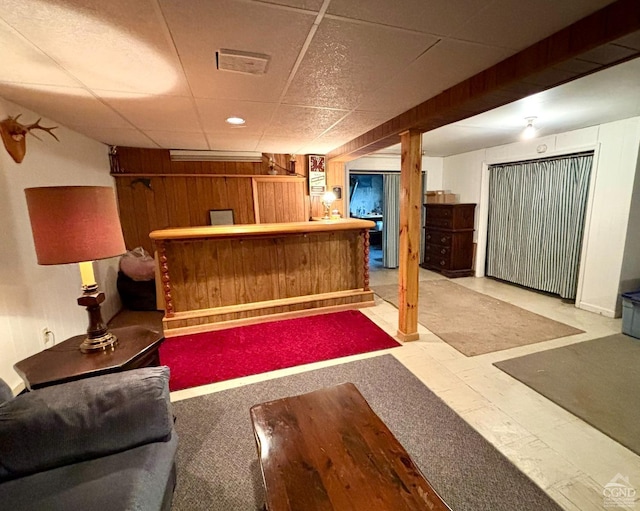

[25,186,126,353]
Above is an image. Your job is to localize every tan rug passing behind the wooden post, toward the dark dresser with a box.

[373,280,583,357]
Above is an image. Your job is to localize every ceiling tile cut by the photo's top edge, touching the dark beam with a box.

[451,0,611,52]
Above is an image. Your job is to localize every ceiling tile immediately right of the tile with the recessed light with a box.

[264,105,347,140]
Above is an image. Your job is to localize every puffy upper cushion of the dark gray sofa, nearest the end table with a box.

[0,367,173,480]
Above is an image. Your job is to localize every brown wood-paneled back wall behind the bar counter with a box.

[112,147,320,253]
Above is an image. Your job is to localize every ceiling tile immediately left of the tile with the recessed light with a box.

[96,91,201,132]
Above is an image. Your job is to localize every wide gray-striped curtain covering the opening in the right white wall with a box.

[486,153,593,299]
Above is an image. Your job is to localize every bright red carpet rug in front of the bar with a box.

[160,310,400,391]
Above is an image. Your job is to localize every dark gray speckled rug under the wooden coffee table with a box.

[172,355,561,511]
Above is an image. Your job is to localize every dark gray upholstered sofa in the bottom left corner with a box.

[0,367,178,511]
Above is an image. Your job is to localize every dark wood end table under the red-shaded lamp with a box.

[13,326,164,390]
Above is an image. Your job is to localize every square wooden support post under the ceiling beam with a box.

[398,130,422,341]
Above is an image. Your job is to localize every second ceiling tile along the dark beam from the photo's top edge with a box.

[358,39,510,115]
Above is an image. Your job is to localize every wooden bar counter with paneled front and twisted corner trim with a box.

[150,219,375,337]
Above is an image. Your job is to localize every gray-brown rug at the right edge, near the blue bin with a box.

[494,334,640,454]
